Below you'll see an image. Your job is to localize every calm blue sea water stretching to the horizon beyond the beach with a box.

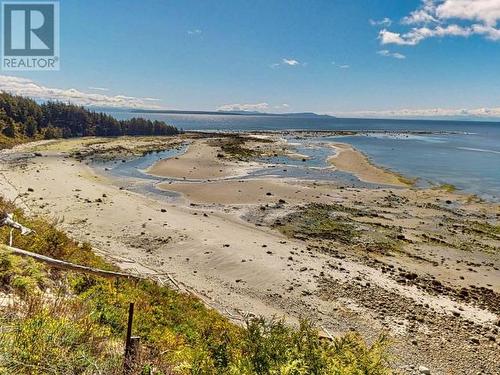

[106,112,500,201]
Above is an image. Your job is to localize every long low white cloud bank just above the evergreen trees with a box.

[0,75,161,109]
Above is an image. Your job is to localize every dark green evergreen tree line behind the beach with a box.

[0,92,179,139]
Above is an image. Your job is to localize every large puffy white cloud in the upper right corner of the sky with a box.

[379,0,500,46]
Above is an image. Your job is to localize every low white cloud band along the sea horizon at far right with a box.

[335,107,500,119]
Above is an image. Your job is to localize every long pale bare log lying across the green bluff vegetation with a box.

[0,244,143,279]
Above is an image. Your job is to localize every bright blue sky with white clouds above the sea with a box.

[0,0,500,118]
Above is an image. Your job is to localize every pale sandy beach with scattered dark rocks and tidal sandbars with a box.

[0,136,500,374]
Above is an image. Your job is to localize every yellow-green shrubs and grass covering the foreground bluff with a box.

[0,199,390,375]
